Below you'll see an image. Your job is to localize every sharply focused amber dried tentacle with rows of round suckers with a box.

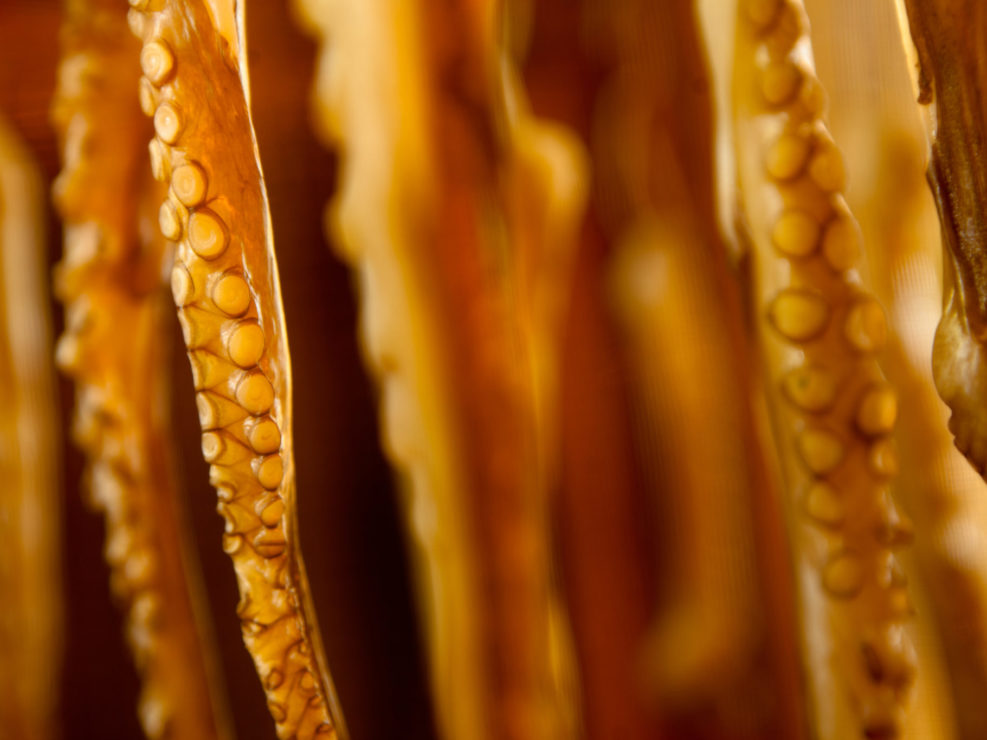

[128,0,346,738]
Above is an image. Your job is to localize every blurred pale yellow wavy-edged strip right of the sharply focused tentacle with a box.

[295,2,487,738]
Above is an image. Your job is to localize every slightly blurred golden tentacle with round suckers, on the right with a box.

[718,0,914,738]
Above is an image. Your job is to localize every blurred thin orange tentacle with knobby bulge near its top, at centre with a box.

[499,15,589,737]
